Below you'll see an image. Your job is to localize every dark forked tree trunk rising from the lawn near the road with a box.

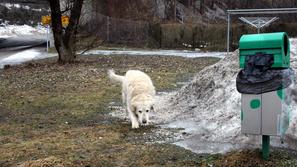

[48,0,84,63]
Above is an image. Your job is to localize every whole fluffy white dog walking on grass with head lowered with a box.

[108,70,156,128]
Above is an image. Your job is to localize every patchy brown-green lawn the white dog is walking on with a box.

[0,56,297,167]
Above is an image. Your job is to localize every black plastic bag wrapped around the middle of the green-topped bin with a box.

[236,53,294,94]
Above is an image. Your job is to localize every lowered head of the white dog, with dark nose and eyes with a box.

[133,102,154,125]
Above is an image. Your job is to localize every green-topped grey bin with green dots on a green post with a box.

[236,32,291,159]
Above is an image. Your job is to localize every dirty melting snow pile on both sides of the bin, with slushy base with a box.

[155,40,297,153]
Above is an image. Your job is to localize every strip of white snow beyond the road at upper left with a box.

[0,25,47,38]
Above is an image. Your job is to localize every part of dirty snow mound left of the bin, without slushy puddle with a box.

[156,52,243,149]
